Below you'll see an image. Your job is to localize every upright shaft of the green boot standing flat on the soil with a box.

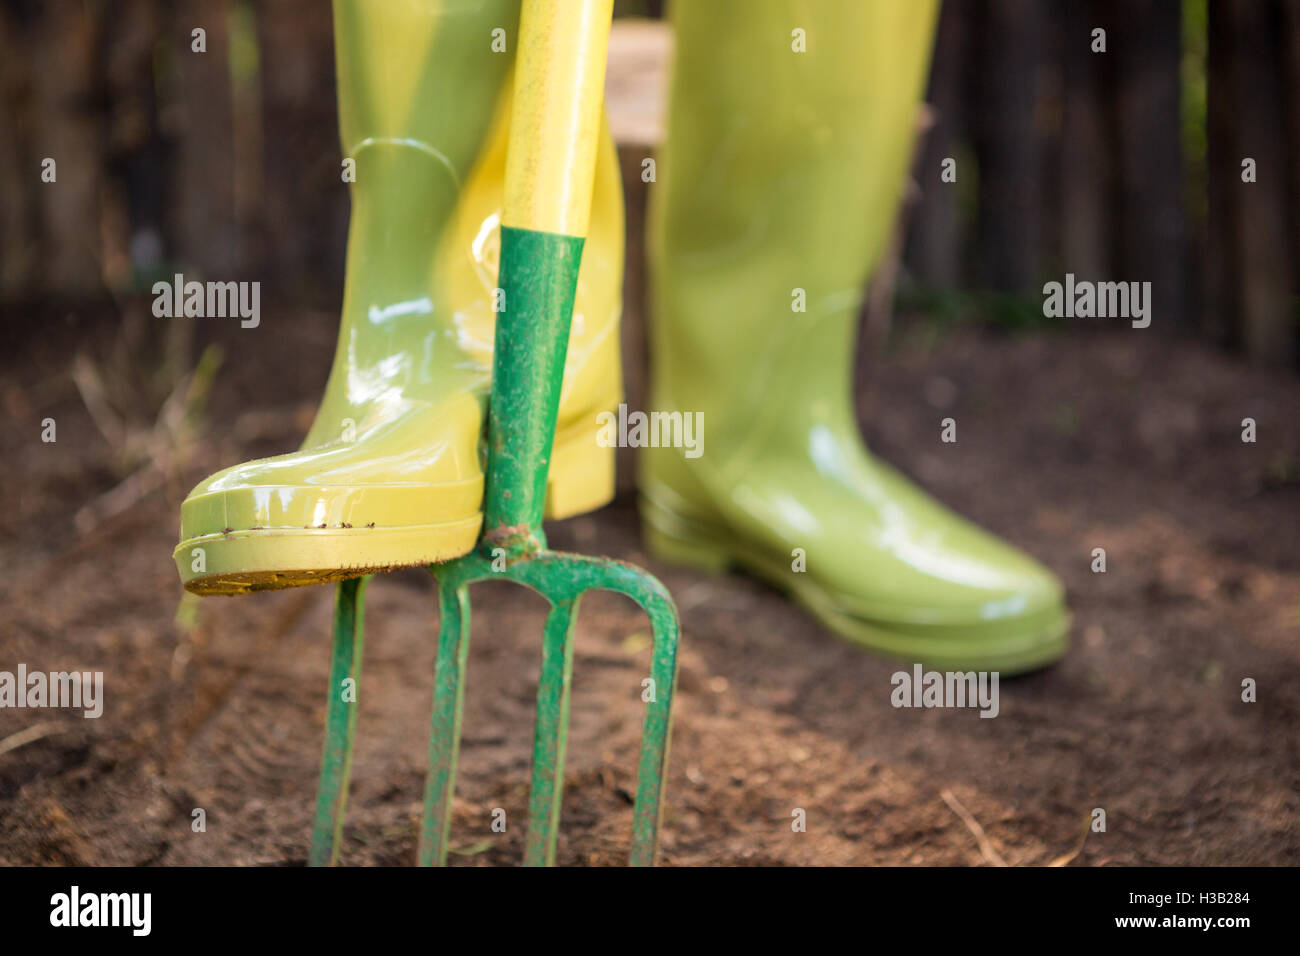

[650,0,937,455]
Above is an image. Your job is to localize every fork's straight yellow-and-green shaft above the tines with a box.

[484,0,612,554]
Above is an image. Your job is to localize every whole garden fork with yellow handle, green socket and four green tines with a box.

[309,0,679,865]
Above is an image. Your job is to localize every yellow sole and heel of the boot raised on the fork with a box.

[173,429,615,594]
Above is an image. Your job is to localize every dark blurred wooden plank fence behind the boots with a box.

[0,0,1300,368]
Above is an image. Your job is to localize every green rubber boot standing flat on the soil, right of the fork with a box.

[641,0,1069,672]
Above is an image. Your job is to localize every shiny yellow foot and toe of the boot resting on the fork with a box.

[173,412,484,594]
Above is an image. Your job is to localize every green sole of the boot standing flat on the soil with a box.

[641,497,1070,675]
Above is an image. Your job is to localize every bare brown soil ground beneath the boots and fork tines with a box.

[0,311,1300,865]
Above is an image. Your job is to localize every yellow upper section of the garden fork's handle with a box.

[502,0,614,237]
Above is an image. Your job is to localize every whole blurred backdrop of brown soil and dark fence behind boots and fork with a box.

[0,0,1300,865]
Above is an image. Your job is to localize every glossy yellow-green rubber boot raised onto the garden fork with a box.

[174,0,623,594]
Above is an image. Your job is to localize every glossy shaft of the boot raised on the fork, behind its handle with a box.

[306,0,623,446]
